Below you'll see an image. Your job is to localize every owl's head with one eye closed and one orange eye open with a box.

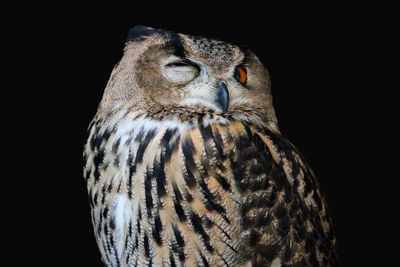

[99,26,276,127]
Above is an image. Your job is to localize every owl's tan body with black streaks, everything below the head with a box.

[84,110,338,266]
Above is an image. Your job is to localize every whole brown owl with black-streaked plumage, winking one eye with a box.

[84,26,337,267]
